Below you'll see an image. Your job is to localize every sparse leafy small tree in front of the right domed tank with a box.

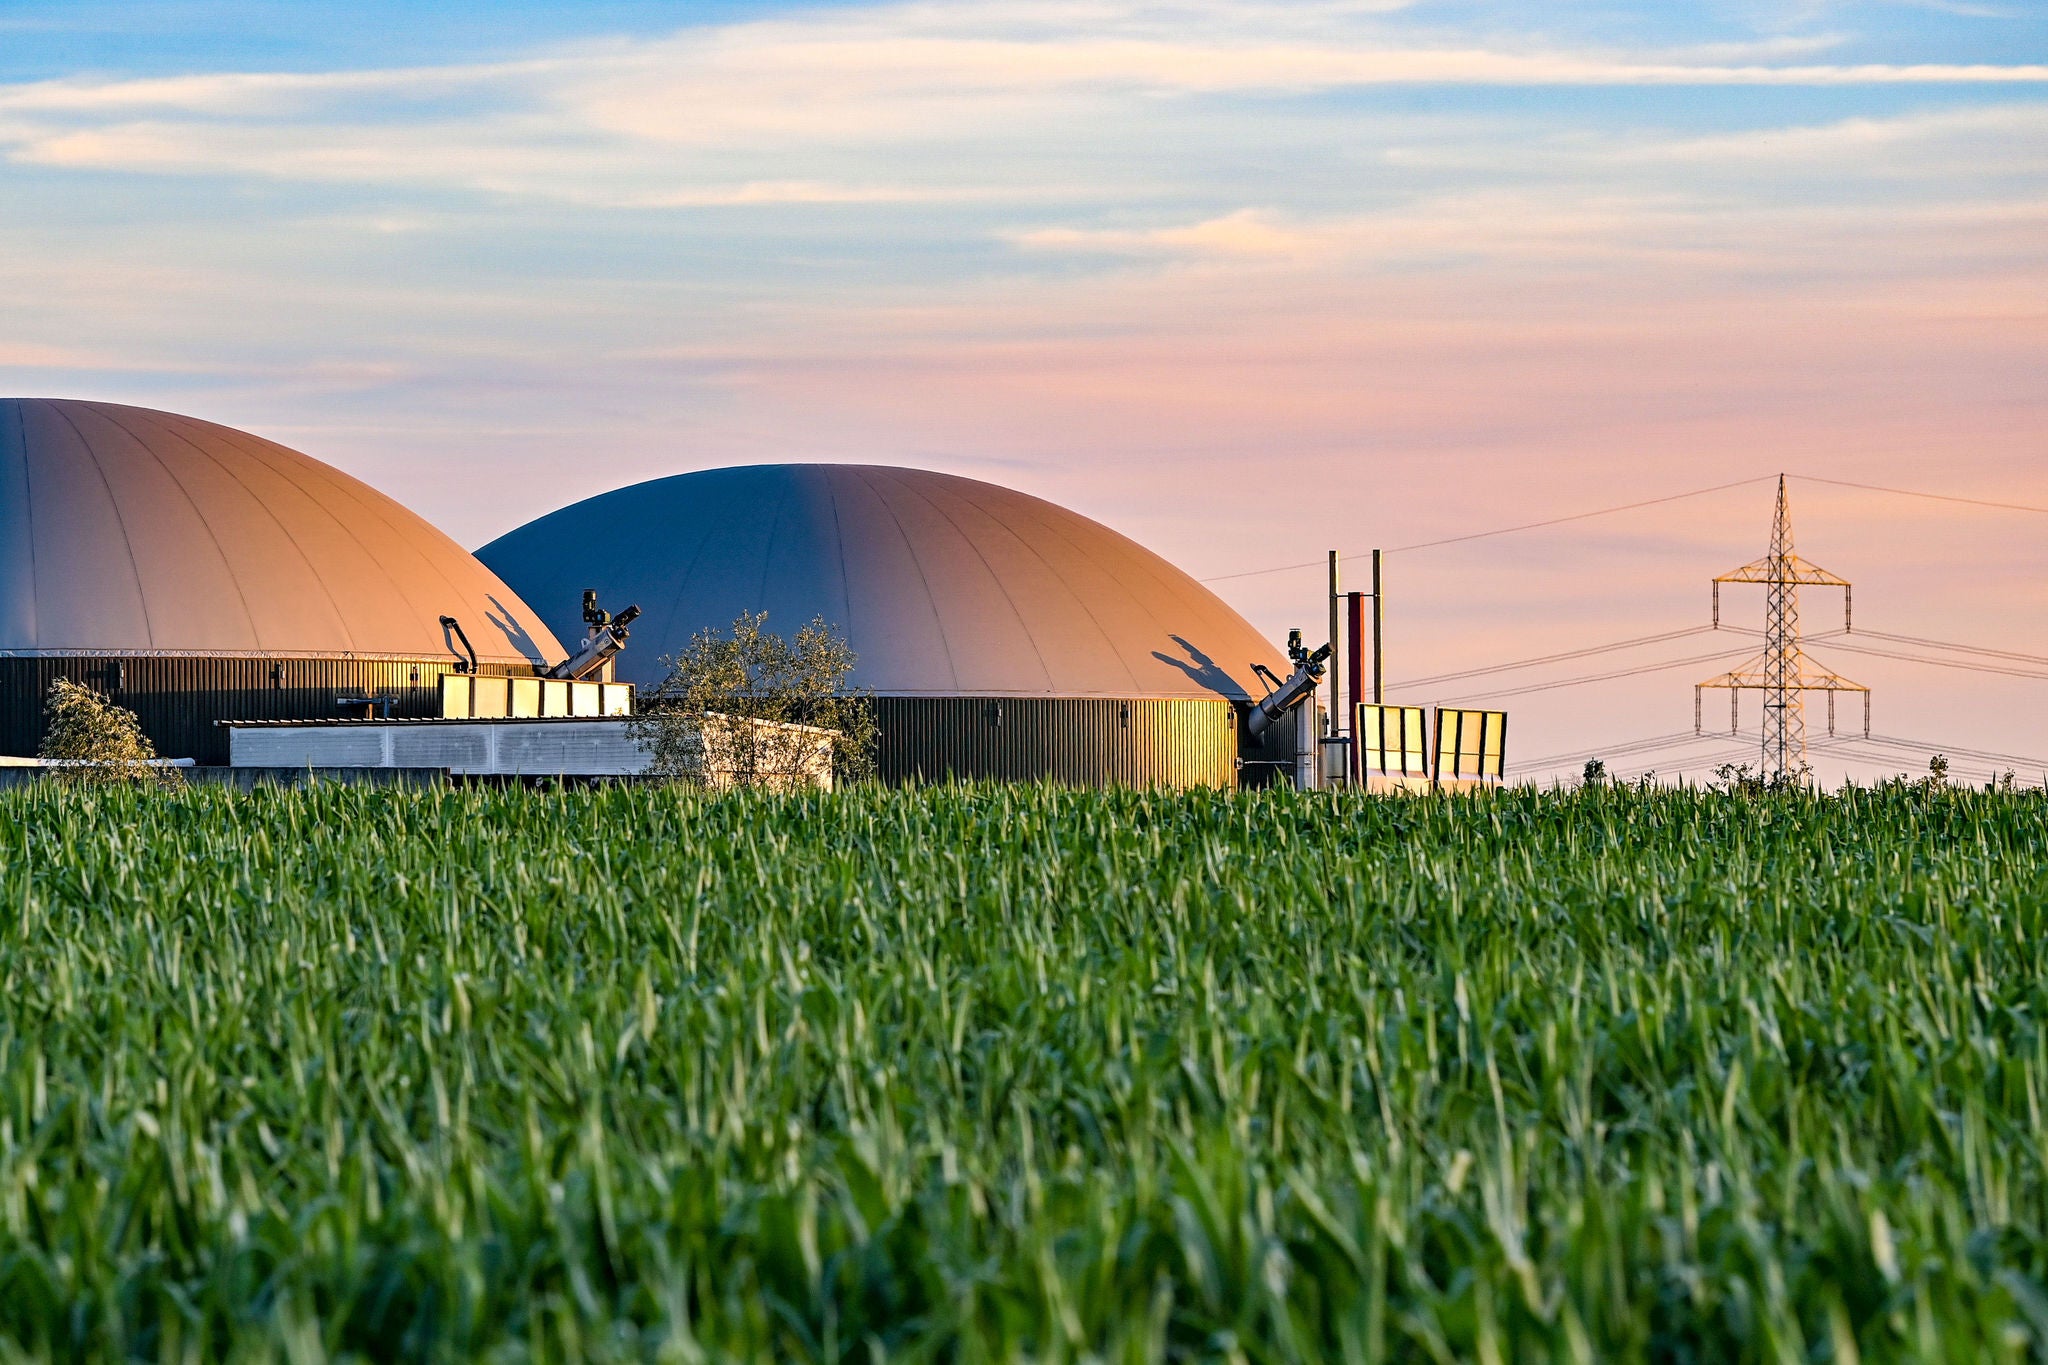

[635,612,877,788]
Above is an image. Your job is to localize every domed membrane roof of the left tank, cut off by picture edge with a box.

[0,399,573,663]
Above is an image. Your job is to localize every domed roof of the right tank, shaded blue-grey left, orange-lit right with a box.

[477,465,1282,700]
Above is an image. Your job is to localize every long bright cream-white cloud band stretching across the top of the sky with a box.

[0,0,2048,207]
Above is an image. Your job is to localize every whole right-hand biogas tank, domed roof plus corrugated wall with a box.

[477,465,1294,786]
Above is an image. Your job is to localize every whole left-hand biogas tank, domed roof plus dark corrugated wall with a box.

[0,399,575,763]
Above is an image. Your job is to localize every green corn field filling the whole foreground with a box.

[0,786,2048,1363]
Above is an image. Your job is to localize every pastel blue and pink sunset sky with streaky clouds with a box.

[0,0,2048,780]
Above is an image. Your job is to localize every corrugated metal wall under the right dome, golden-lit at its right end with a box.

[874,696,1239,786]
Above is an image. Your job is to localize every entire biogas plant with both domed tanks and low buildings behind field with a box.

[0,399,1499,788]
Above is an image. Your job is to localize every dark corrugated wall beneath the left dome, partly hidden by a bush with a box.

[0,657,536,763]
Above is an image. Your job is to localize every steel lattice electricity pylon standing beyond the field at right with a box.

[1692,475,1870,782]
